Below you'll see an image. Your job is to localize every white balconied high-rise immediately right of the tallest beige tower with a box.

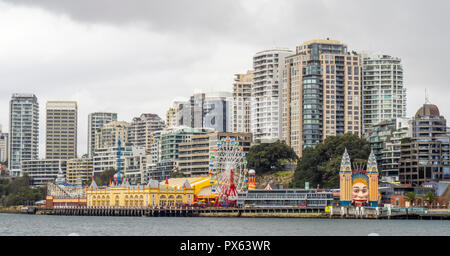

[361,54,406,135]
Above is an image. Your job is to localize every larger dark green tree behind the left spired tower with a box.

[290,133,370,188]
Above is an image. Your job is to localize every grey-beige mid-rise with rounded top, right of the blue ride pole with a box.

[128,114,166,153]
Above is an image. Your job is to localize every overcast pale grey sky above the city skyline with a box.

[0,0,450,157]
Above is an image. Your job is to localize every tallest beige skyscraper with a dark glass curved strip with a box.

[281,39,361,156]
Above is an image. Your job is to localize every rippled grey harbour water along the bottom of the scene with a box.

[0,213,450,236]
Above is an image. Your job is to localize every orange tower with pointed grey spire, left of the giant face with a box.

[339,148,352,206]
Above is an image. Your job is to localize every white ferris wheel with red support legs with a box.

[209,137,248,205]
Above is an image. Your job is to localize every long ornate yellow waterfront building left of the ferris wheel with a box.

[46,176,236,207]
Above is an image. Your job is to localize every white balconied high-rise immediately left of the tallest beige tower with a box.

[250,48,293,141]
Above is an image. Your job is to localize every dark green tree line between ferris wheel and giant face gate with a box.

[247,133,370,188]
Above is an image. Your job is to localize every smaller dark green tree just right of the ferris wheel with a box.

[247,141,298,174]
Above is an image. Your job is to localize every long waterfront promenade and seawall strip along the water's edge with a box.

[7,207,450,220]
